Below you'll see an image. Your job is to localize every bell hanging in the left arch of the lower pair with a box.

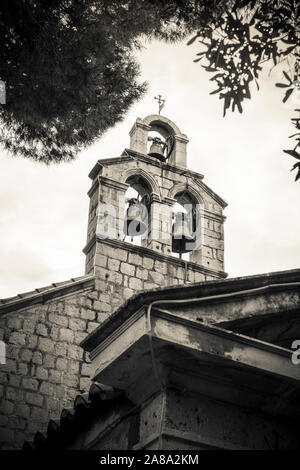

[124,198,148,238]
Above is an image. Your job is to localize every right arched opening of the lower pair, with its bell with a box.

[172,191,201,261]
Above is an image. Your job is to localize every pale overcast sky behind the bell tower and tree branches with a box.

[0,39,300,298]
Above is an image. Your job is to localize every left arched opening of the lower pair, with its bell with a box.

[123,175,151,246]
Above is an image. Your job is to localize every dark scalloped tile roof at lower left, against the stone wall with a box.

[23,383,127,451]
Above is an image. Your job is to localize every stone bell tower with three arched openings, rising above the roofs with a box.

[84,114,227,303]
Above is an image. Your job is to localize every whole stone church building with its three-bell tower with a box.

[0,114,300,450]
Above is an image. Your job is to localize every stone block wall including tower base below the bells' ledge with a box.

[0,235,225,448]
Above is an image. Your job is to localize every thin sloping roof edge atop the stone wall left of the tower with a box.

[0,275,95,315]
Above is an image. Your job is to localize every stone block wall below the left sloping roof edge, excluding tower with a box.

[0,291,102,449]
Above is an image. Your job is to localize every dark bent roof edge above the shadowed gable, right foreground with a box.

[80,269,300,352]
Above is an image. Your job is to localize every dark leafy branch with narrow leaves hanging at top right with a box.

[188,0,300,180]
